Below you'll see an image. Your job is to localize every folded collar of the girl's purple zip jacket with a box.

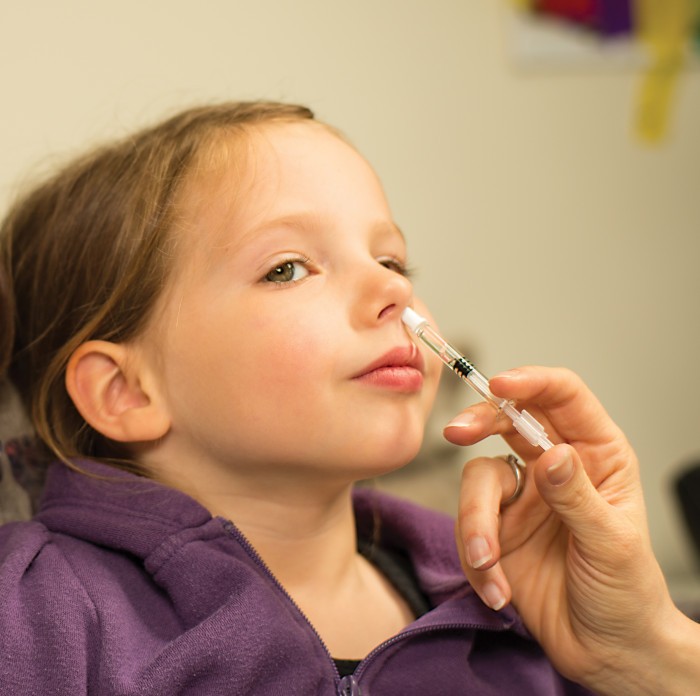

[36,460,526,633]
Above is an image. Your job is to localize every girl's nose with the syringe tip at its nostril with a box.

[358,262,413,324]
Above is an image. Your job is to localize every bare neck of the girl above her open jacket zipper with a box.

[148,456,414,659]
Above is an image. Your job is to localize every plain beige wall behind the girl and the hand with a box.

[0,0,700,576]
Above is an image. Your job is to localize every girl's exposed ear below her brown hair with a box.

[66,341,170,442]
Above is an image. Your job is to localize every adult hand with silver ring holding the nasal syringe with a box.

[445,367,700,696]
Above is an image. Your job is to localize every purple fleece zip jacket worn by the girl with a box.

[0,462,587,696]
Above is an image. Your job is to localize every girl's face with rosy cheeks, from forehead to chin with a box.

[145,123,440,480]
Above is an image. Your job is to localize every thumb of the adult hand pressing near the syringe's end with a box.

[535,445,610,550]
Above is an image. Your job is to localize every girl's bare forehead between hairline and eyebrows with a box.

[180,121,385,243]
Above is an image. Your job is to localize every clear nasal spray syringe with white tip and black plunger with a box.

[401,307,554,450]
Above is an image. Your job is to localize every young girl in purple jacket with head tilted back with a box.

[0,103,596,696]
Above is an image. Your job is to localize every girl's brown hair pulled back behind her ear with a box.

[0,102,314,470]
